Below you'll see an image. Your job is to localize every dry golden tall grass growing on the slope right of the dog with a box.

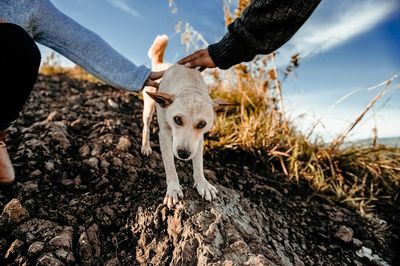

[200,1,400,214]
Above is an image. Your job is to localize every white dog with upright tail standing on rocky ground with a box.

[142,35,233,208]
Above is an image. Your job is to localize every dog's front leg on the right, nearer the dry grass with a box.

[192,137,218,201]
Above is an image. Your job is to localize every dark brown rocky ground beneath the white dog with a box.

[0,76,400,265]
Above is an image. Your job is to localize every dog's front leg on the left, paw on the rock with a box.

[159,126,183,209]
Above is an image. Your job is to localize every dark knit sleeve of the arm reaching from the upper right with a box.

[208,0,321,69]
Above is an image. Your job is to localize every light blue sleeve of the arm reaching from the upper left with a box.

[34,0,151,91]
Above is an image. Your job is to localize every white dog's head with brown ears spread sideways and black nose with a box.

[147,89,236,160]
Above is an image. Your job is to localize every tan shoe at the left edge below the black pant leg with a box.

[0,131,15,185]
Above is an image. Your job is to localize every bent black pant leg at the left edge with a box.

[0,23,41,131]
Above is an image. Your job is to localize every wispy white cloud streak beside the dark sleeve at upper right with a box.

[280,0,399,62]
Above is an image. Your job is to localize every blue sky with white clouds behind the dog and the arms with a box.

[41,0,400,140]
